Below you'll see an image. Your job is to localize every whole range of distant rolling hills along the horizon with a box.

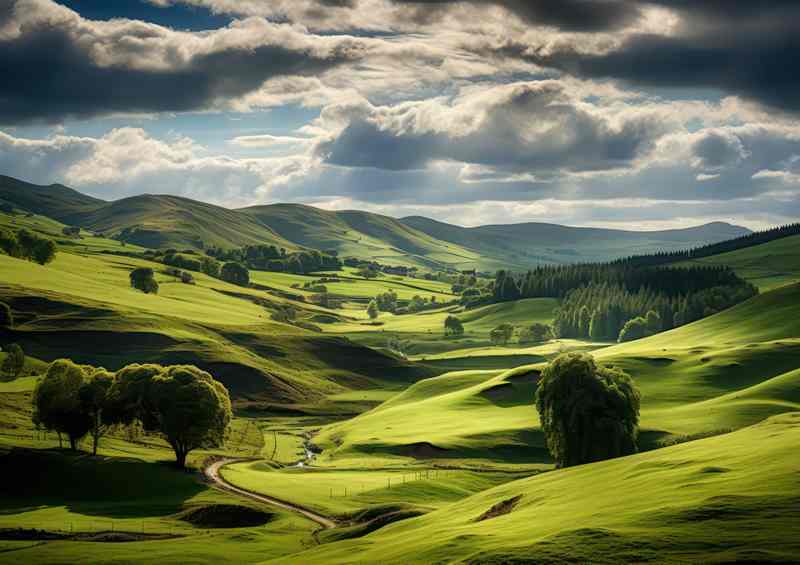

[0,176,751,271]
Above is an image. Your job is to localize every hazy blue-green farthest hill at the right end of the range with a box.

[400,216,750,268]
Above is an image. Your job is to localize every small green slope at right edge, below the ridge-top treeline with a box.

[680,235,800,291]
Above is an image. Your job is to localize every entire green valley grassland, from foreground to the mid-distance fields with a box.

[0,204,800,563]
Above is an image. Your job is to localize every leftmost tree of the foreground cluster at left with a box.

[32,359,91,451]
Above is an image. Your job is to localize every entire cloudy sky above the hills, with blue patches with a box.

[0,0,800,229]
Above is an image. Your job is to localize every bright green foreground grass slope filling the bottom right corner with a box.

[294,413,800,563]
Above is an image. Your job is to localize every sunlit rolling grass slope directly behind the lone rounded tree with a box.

[317,285,800,465]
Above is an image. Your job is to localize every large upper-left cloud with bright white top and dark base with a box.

[0,0,366,125]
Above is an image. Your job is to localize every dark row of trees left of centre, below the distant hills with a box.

[206,245,342,274]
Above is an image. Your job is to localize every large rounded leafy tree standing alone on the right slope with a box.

[536,353,640,467]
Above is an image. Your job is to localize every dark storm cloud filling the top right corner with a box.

[495,0,800,112]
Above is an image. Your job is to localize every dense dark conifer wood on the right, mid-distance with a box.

[493,263,758,341]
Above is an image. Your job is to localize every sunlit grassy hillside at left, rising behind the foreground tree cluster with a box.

[0,252,432,404]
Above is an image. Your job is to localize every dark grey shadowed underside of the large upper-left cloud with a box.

[0,1,358,125]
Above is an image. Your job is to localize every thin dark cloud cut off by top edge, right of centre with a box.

[392,0,640,31]
